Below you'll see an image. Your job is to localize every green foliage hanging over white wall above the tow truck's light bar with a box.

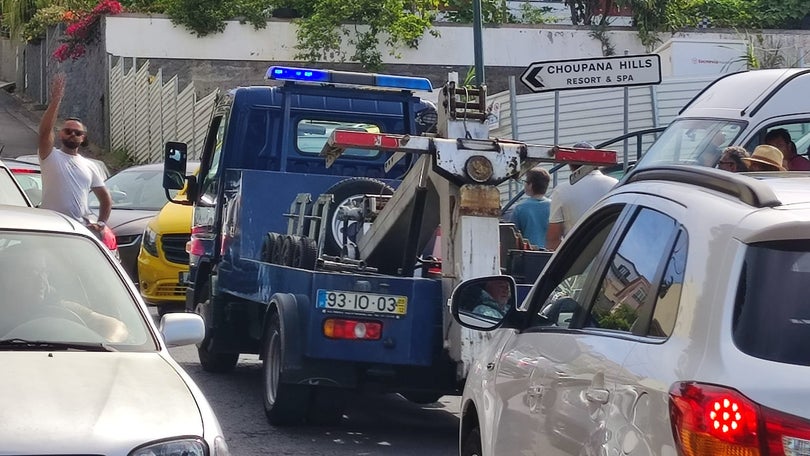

[296,0,438,70]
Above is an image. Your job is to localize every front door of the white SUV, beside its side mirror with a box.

[489,198,627,454]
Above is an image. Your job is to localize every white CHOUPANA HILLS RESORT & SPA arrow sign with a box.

[520,54,661,92]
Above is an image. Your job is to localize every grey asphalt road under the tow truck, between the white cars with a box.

[166,334,459,456]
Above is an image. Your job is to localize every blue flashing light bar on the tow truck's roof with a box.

[267,66,433,92]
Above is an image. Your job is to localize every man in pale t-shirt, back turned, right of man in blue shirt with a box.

[545,142,618,250]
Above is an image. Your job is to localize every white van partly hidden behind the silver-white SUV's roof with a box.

[628,68,810,173]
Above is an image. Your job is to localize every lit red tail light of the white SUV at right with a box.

[669,382,810,456]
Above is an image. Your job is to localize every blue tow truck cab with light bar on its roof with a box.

[186,67,436,304]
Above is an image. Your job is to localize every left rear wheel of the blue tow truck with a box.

[262,314,312,426]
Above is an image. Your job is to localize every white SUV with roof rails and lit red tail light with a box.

[451,165,810,456]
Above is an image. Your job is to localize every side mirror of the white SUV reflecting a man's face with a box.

[450,275,517,331]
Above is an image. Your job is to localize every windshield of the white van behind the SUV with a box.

[636,119,745,169]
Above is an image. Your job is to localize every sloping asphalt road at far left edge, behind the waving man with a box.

[0,90,38,159]
